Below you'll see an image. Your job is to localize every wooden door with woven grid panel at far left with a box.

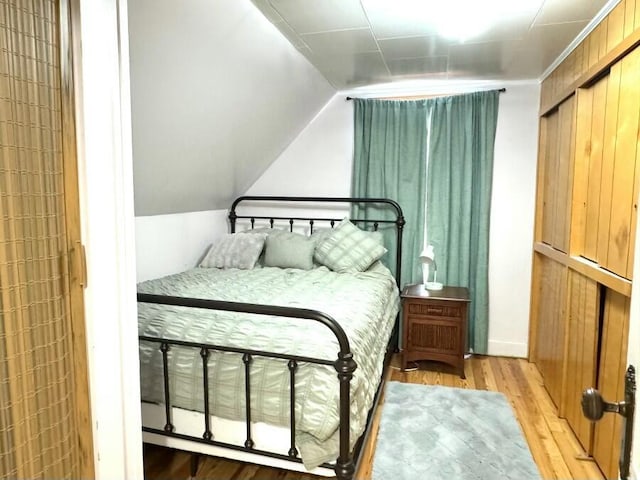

[0,0,94,479]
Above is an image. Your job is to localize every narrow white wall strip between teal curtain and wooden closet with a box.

[489,83,540,357]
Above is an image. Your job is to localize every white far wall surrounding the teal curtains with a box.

[249,82,540,357]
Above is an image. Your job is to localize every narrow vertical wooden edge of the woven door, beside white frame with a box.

[59,0,95,479]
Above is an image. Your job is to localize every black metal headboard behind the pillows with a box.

[229,195,405,288]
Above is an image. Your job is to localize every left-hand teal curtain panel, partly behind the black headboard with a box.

[351,99,431,285]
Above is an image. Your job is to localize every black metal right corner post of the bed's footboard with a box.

[334,351,356,480]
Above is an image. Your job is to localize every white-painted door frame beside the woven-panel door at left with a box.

[67,0,143,479]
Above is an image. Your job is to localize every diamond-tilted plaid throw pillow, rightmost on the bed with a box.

[314,218,387,272]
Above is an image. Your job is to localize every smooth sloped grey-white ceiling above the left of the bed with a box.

[128,0,335,216]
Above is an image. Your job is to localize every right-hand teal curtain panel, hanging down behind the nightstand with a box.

[426,91,499,354]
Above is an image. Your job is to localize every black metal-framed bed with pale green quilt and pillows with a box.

[138,197,404,479]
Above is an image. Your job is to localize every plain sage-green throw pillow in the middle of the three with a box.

[263,232,316,270]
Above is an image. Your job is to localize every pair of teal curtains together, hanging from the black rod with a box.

[351,90,499,354]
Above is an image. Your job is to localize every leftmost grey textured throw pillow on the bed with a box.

[200,233,267,270]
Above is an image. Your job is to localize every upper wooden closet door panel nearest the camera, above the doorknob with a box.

[572,48,640,279]
